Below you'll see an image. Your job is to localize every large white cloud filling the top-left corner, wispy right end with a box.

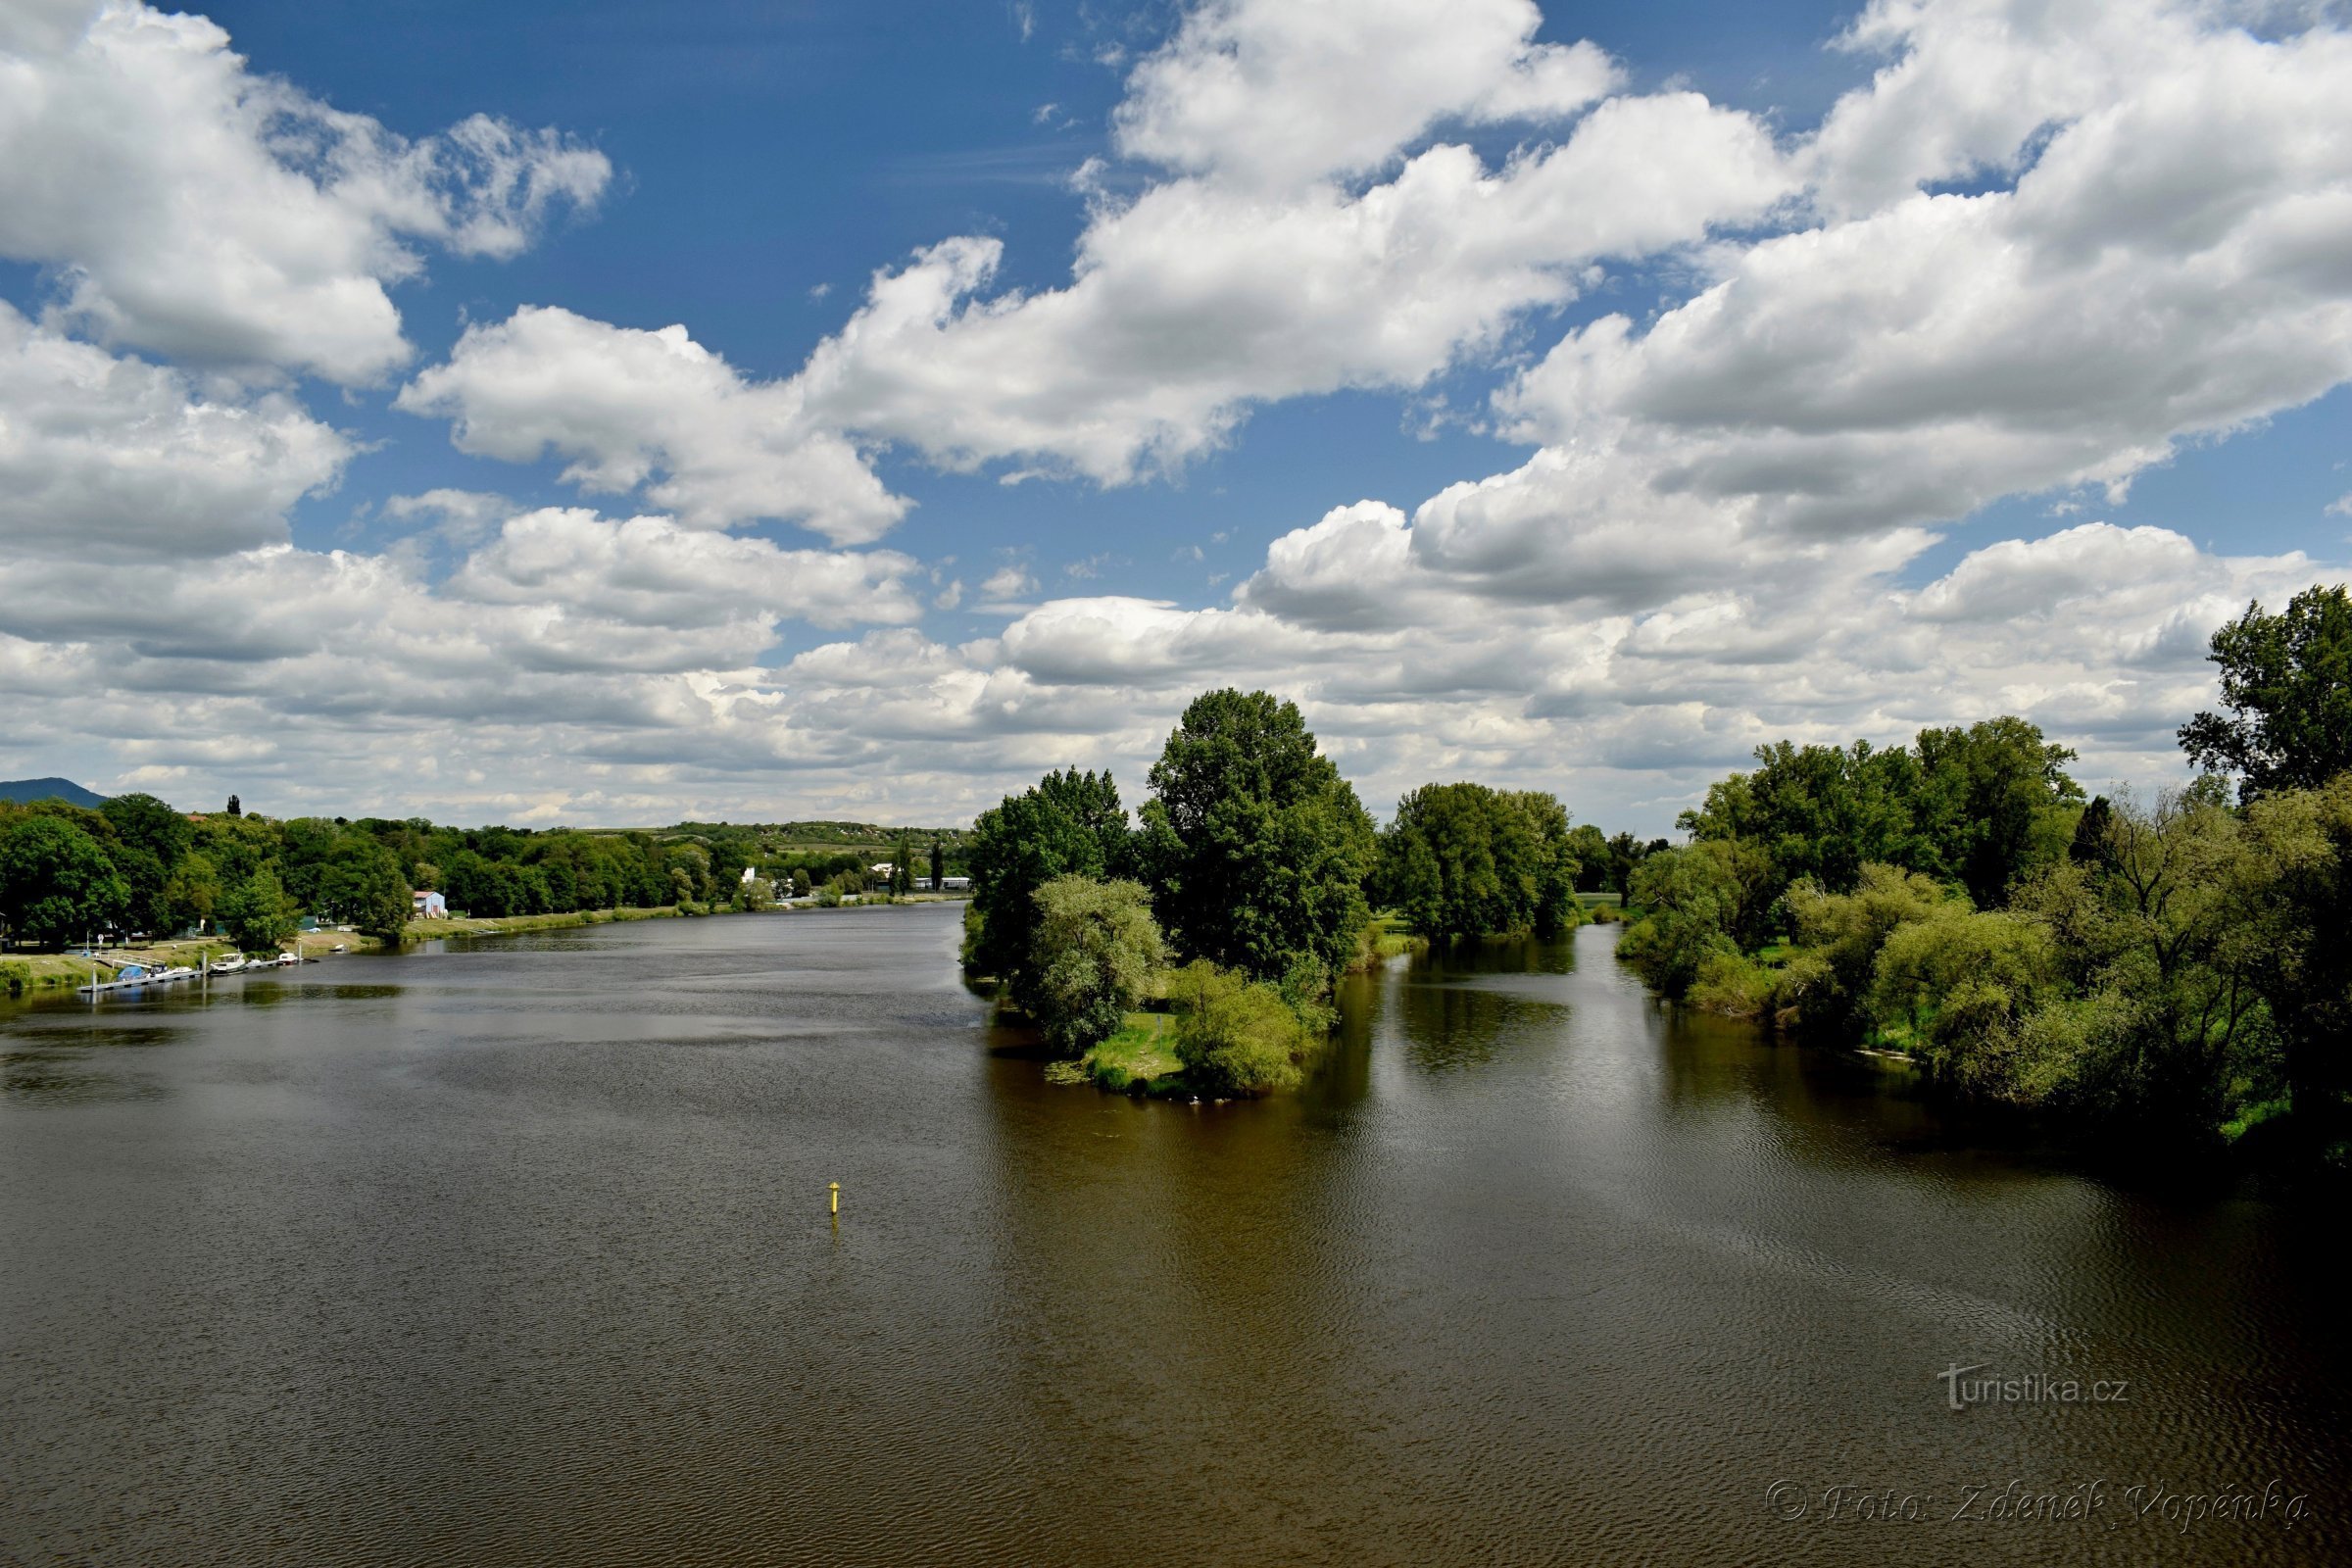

[0,0,612,383]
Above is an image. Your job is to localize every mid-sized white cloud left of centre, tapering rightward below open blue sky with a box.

[393,306,907,543]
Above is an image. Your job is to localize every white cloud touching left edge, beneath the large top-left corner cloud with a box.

[0,303,353,557]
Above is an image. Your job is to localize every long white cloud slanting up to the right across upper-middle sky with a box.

[800,94,1792,484]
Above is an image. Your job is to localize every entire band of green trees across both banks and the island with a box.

[0,585,2352,1168]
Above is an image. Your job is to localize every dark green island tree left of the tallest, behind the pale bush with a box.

[964,768,1131,985]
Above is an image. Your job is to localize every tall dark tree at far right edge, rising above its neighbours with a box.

[2180,583,2352,800]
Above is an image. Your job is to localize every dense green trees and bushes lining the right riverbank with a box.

[1618,585,2352,1166]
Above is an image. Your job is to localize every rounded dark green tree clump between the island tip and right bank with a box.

[1374,783,1606,938]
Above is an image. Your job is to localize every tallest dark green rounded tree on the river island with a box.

[1139,689,1378,980]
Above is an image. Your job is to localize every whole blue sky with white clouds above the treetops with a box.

[0,0,2352,835]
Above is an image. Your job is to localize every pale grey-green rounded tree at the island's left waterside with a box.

[1013,877,1166,1055]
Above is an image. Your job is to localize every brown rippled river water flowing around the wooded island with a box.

[0,906,2352,1568]
